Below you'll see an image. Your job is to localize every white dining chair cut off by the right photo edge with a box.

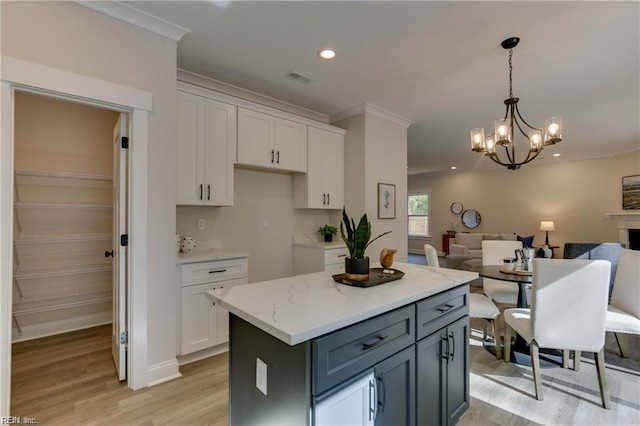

[605,249,640,357]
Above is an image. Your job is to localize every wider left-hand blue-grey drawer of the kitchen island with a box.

[312,305,415,395]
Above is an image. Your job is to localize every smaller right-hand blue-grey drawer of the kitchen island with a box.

[416,285,469,340]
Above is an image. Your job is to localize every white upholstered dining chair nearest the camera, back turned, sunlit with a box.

[503,259,611,409]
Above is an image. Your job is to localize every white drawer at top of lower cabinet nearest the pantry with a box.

[180,259,248,287]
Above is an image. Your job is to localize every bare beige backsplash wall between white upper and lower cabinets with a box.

[176,168,338,282]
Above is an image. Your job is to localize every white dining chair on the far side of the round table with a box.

[482,240,531,306]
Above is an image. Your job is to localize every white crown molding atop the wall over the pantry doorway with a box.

[73,0,191,41]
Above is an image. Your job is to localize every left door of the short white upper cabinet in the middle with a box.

[238,108,275,167]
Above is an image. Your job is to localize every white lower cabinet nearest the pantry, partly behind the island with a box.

[178,258,248,355]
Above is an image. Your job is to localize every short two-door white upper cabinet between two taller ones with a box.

[237,108,307,173]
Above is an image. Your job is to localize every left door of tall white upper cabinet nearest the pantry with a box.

[176,92,205,204]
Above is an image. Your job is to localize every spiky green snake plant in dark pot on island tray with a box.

[340,208,391,281]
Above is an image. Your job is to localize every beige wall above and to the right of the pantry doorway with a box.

[1,2,177,380]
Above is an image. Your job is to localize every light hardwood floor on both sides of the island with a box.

[11,322,640,425]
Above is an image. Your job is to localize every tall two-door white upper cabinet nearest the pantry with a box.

[176,91,237,206]
